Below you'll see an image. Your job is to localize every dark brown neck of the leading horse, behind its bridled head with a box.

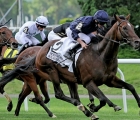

[99,26,119,60]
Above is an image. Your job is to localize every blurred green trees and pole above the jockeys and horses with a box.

[0,0,140,35]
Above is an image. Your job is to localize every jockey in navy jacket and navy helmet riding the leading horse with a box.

[64,10,109,59]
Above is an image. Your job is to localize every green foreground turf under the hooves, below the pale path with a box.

[0,98,140,120]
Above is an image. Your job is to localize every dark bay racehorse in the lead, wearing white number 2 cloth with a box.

[0,15,140,120]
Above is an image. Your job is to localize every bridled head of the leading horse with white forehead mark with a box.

[114,15,140,49]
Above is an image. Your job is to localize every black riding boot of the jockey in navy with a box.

[64,43,81,60]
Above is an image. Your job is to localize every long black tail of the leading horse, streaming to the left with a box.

[0,57,35,87]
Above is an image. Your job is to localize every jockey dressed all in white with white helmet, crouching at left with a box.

[15,16,49,53]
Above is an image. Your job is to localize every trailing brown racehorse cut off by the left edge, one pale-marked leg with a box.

[0,25,18,109]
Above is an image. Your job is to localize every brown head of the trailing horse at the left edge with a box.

[0,26,18,49]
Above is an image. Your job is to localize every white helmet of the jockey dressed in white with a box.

[35,16,49,27]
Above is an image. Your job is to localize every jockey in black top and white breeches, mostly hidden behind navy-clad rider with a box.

[48,22,70,41]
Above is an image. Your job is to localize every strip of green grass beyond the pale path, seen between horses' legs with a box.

[2,64,140,94]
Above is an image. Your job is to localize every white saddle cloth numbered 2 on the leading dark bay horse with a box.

[46,37,80,72]
